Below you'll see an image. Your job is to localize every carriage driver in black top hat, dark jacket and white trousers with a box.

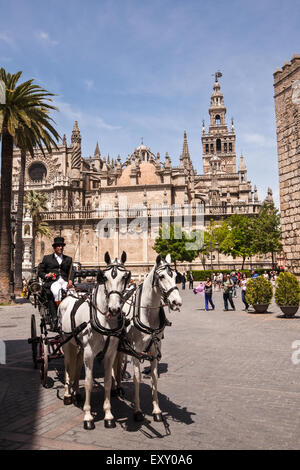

[38,237,74,328]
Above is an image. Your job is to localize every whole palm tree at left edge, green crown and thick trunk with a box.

[0,68,59,302]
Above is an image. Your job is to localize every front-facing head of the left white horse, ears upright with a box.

[97,251,131,316]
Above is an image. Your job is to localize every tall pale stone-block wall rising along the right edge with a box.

[274,54,300,276]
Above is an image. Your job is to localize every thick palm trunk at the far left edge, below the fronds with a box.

[0,125,13,303]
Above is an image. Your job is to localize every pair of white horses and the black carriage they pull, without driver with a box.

[28,252,181,429]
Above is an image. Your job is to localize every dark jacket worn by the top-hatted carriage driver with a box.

[38,253,75,286]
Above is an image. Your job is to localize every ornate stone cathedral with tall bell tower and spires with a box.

[12,73,272,276]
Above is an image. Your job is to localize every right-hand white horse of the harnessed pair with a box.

[116,255,182,421]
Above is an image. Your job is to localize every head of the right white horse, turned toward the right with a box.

[153,255,182,310]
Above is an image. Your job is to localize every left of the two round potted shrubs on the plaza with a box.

[246,276,273,313]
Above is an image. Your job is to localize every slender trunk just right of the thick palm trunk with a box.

[15,150,26,293]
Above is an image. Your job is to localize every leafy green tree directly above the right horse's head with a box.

[153,224,201,269]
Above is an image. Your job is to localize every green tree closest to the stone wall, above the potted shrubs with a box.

[253,202,282,267]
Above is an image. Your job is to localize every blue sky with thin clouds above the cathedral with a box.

[0,0,300,204]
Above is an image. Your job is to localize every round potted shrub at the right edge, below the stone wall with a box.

[275,272,300,317]
